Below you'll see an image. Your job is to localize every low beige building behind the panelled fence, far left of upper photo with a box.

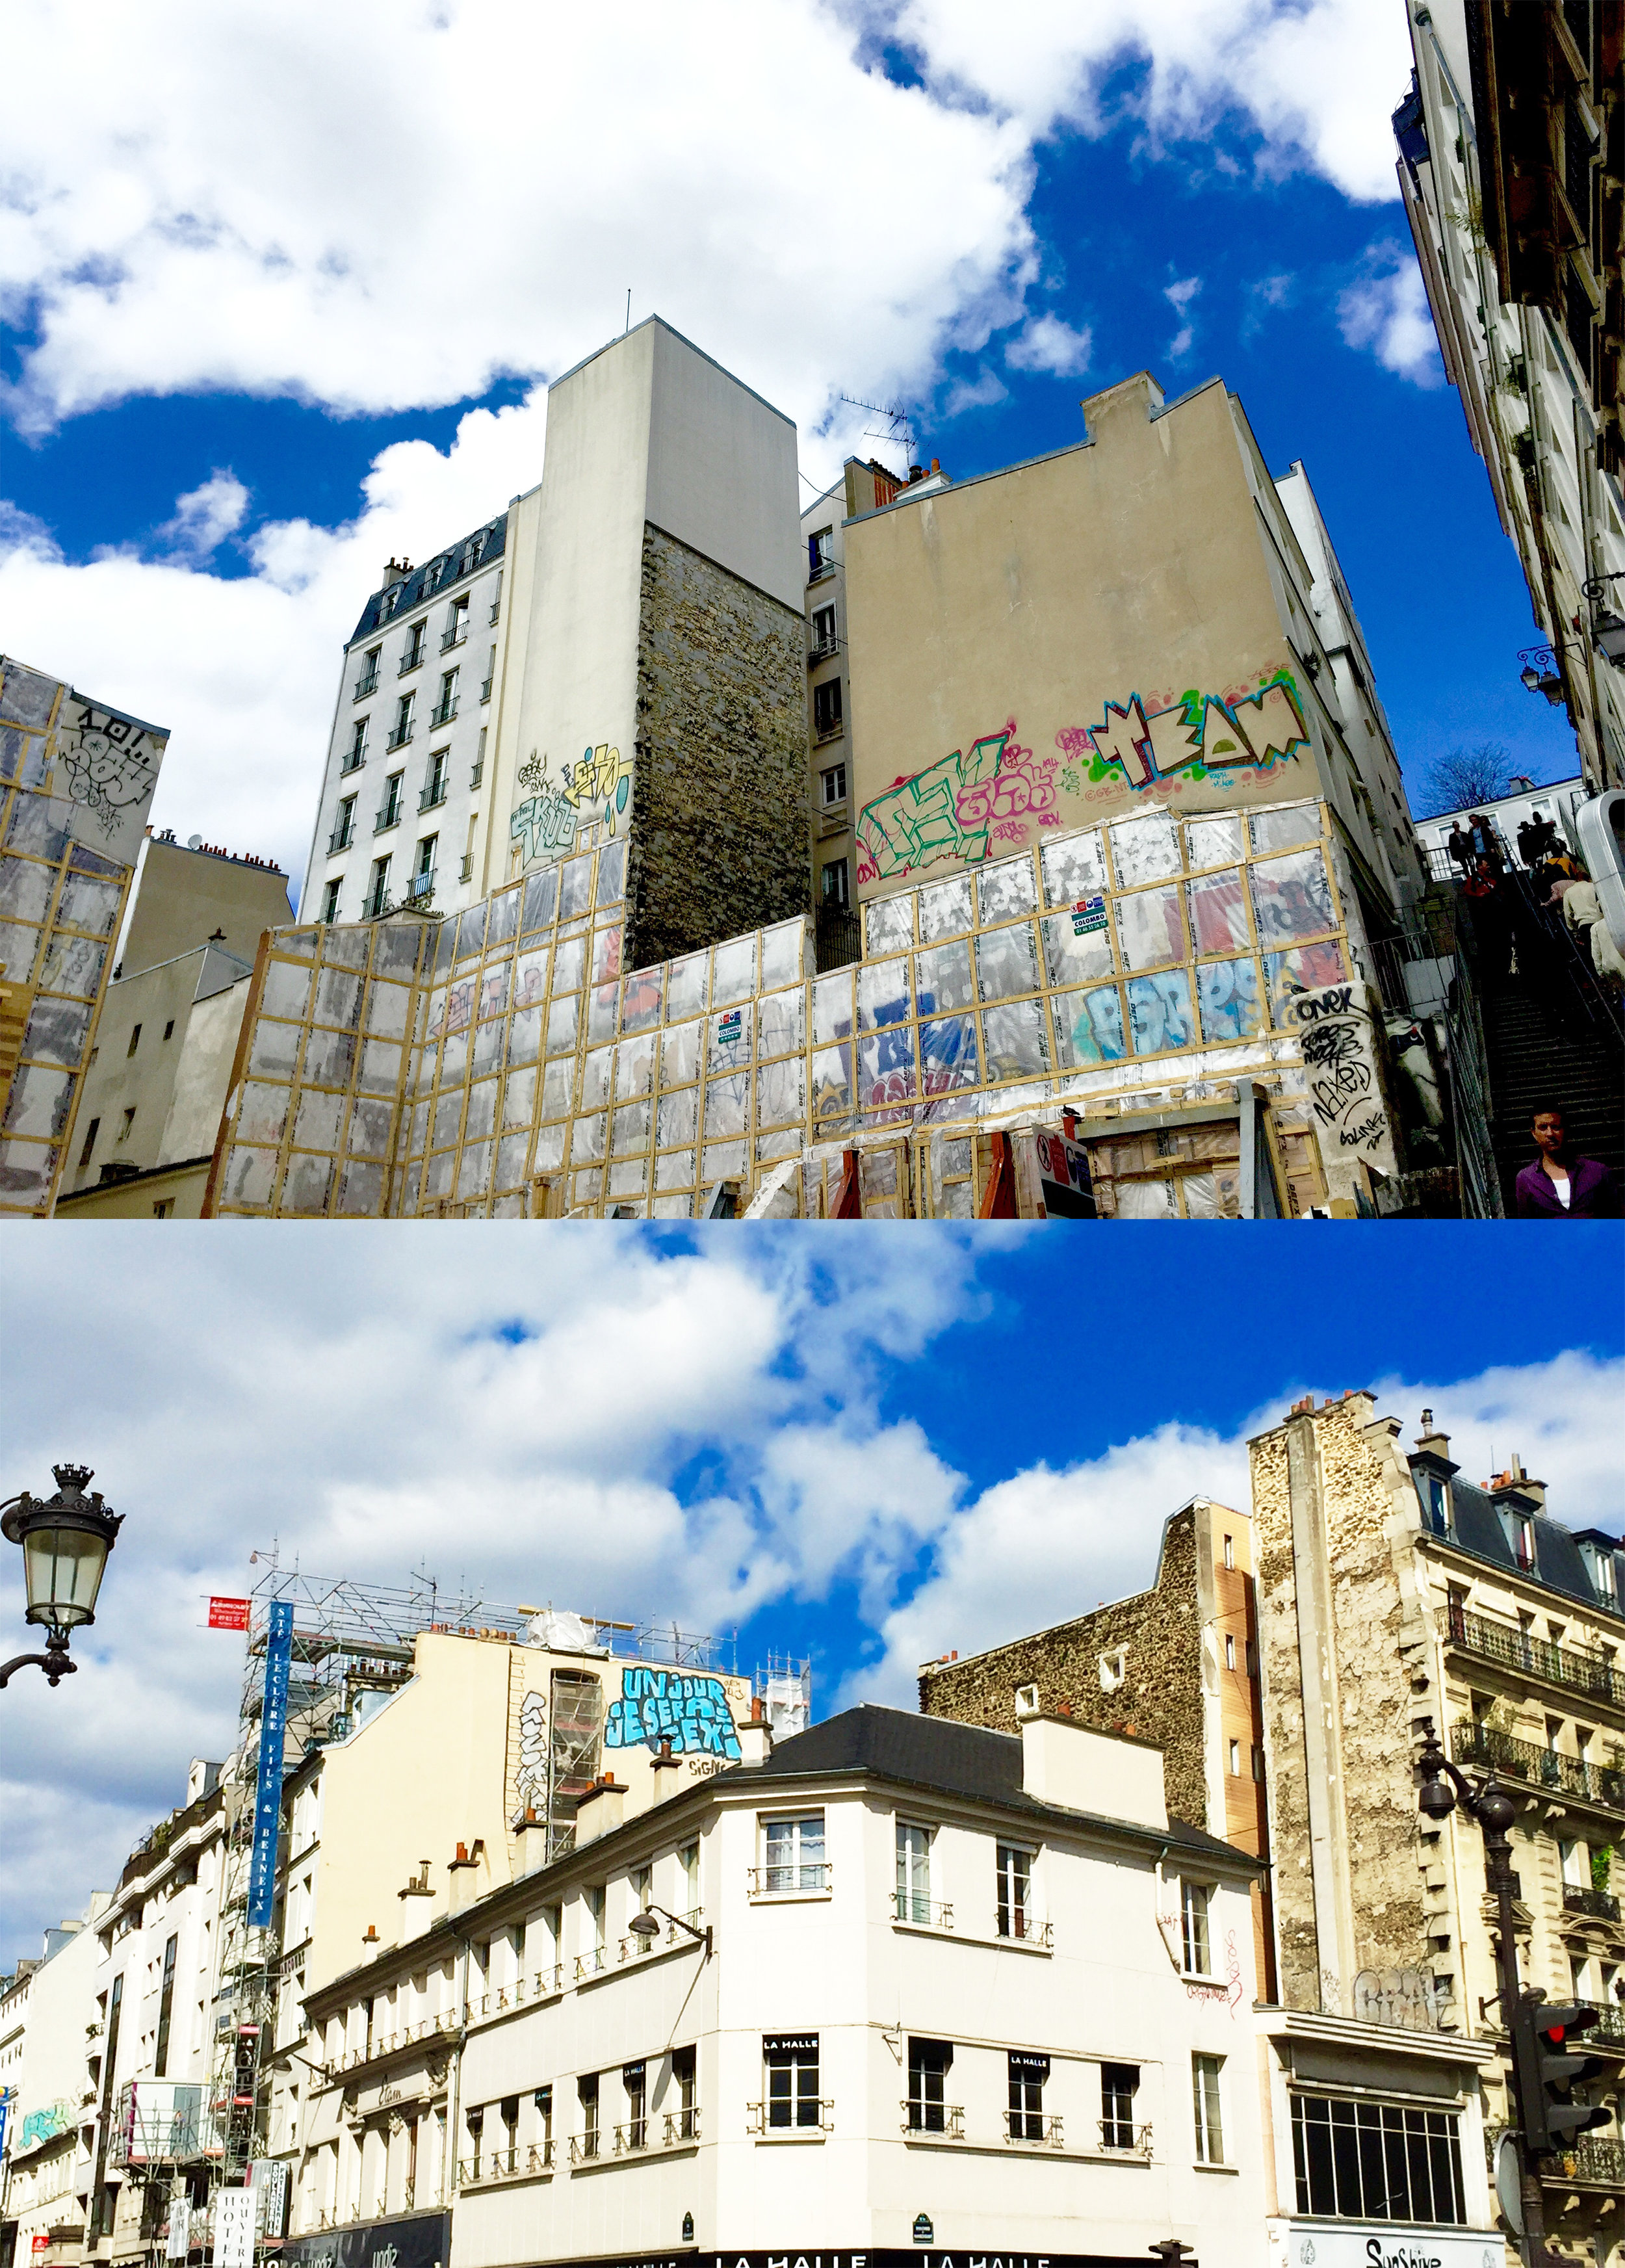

[59,832,290,1220]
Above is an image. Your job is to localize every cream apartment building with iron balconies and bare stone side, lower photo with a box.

[1249,1392,1625,2261]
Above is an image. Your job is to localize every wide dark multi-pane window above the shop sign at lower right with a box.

[1292,2096,1466,2227]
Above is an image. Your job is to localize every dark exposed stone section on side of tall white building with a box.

[625,526,811,969]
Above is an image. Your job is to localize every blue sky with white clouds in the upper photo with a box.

[0,0,1575,893]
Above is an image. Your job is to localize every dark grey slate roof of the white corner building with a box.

[725,1701,1260,1869]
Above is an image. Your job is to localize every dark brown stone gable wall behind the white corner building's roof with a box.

[920,1506,1224,1835]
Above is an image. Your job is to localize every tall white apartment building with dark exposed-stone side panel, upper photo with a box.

[302,317,807,966]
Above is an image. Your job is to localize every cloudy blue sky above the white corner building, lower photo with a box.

[0,1223,1625,1964]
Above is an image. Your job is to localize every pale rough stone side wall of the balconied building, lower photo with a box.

[1251,1395,1430,2014]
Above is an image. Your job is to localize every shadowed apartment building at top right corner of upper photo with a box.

[1394,0,1625,794]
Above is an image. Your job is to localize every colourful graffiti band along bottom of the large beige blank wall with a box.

[857,669,1308,882]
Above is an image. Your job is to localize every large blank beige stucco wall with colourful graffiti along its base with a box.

[846,374,1328,896]
